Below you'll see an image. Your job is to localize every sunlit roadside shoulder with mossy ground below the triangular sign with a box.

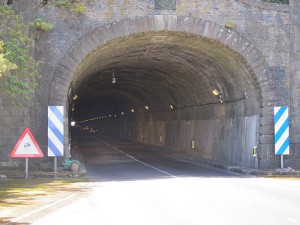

[0,171,89,224]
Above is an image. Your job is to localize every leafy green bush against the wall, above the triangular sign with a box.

[0,5,40,106]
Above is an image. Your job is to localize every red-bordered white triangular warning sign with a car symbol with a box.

[10,128,44,158]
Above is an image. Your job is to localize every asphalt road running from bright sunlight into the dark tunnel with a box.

[33,134,300,225]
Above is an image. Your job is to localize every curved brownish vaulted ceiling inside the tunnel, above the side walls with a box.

[72,32,258,120]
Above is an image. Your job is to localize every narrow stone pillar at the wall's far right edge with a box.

[285,0,300,168]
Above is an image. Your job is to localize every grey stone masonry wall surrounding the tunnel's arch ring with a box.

[0,0,296,169]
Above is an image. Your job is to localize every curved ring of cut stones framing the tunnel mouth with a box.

[48,15,277,167]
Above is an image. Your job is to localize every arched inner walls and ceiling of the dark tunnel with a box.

[68,32,260,167]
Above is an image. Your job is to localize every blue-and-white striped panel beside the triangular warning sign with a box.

[48,106,64,157]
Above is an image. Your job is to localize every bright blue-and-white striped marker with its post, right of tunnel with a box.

[274,106,290,168]
